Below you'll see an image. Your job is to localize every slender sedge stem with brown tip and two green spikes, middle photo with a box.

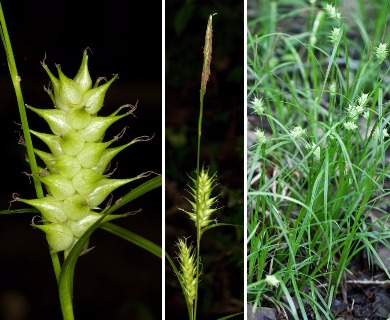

[166,14,242,320]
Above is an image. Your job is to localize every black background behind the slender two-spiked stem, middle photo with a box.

[165,0,244,320]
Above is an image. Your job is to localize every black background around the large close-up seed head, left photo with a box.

[0,0,162,320]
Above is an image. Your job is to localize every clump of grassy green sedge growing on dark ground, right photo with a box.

[247,1,390,319]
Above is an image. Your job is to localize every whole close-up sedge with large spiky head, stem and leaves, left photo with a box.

[0,5,161,320]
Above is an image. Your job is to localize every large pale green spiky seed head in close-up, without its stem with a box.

[15,50,149,257]
